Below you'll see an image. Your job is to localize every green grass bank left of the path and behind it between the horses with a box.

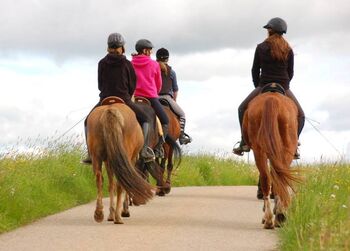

[0,139,257,233]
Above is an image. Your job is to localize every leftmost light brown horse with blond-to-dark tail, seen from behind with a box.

[87,103,154,224]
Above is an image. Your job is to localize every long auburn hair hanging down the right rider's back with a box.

[265,33,292,61]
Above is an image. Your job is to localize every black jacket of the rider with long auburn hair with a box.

[252,41,294,90]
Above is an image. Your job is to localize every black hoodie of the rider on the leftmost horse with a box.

[98,54,136,101]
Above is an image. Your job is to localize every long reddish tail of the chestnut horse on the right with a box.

[258,98,298,207]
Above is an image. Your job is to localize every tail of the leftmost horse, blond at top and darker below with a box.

[101,109,153,205]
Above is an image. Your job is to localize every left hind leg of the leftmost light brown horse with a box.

[92,158,104,222]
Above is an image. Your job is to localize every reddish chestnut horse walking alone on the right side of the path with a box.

[243,92,299,228]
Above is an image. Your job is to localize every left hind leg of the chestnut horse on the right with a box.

[254,150,274,229]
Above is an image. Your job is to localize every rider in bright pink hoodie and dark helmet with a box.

[131,39,169,157]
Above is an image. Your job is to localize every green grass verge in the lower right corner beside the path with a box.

[279,164,350,251]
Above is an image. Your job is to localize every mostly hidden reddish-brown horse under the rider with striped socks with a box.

[158,100,181,196]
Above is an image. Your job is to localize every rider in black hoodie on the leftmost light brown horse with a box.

[83,33,155,163]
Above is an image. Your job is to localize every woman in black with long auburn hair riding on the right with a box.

[233,17,305,159]
